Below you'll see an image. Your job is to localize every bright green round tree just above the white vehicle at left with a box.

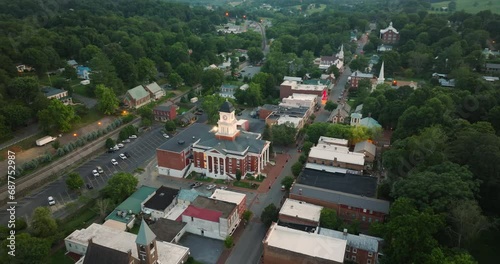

[38,99,76,132]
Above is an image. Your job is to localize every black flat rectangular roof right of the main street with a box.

[297,168,377,197]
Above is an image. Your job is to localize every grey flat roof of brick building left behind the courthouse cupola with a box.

[158,123,214,153]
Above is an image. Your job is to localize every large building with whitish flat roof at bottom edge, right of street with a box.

[262,223,347,264]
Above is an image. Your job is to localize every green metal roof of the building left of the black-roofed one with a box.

[106,186,156,224]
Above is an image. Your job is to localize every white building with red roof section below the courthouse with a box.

[178,196,241,240]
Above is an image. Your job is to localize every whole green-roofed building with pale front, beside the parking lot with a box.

[105,186,156,229]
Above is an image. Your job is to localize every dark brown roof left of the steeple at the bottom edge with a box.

[83,243,132,264]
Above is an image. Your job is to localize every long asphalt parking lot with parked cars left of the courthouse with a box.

[0,125,167,224]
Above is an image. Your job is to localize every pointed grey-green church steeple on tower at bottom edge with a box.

[135,219,158,264]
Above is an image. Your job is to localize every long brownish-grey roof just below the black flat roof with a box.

[290,183,390,214]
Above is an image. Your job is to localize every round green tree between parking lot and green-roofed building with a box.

[102,172,139,203]
